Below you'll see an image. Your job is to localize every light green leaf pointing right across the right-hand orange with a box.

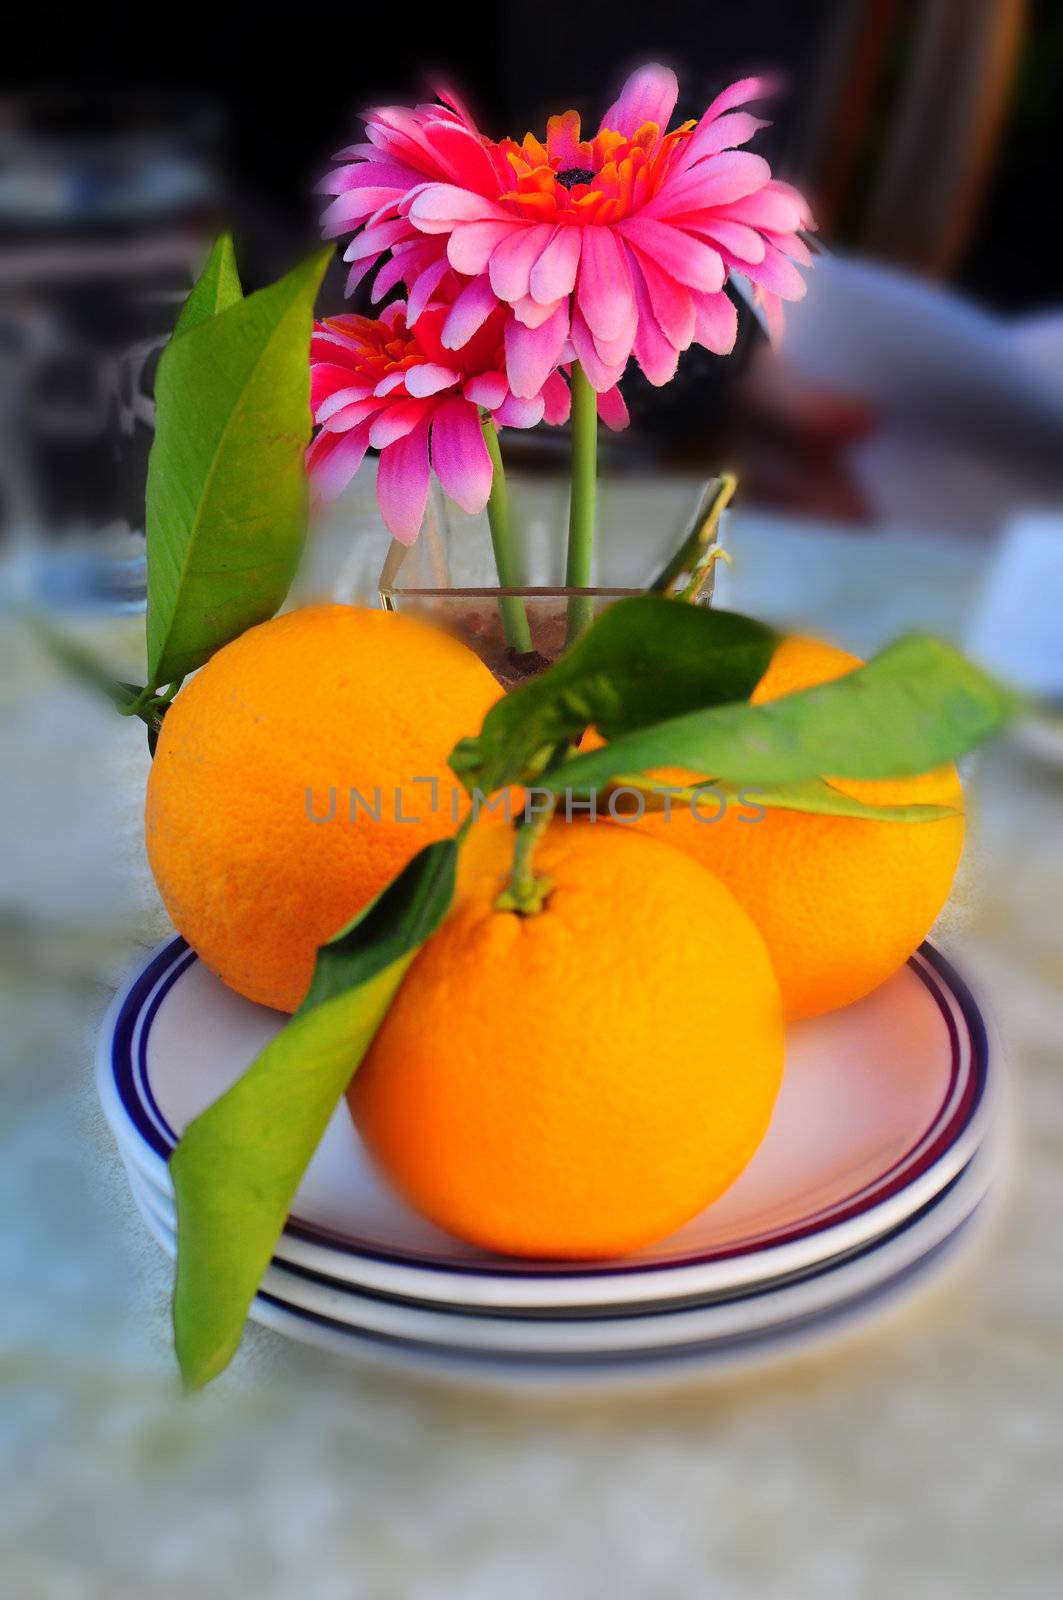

[538,635,1018,792]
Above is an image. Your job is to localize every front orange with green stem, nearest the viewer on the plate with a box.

[349,822,783,1259]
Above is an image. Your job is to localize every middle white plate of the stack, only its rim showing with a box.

[130,1146,996,1357]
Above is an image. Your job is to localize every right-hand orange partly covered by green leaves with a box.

[624,637,964,1018]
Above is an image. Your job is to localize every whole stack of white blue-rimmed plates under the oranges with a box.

[98,939,999,1387]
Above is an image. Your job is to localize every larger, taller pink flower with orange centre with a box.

[325,66,812,395]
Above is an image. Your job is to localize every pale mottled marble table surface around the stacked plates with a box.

[0,499,1063,1600]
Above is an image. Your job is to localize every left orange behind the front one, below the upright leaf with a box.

[146,605,501,1011]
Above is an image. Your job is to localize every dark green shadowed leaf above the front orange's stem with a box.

[451,595,778,792]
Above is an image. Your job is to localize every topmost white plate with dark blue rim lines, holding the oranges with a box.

[98,939,997,1309]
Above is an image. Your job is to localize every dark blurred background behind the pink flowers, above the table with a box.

[0,0,1063,590]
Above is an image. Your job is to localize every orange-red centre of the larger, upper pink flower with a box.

[498,110,695,224]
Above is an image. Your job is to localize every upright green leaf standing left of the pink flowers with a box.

[147,240,331,686]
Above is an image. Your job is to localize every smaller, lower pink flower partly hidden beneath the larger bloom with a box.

[307,301,570,544]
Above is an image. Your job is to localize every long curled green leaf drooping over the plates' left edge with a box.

[170,837,461,1389]
